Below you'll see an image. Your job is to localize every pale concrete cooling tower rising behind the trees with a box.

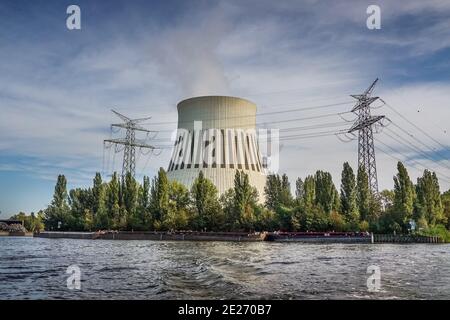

[167,96,266,201]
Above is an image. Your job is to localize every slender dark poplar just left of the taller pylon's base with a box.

[341,162,359,223]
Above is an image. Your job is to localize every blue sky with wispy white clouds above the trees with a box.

[0,0,450,218]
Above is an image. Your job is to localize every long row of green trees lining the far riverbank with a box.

[6,162,450,242]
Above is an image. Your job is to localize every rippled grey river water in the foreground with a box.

[0,237,450,299]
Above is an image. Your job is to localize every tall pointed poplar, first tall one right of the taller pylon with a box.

[392,162,416,231]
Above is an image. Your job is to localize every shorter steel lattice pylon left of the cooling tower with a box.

[104,110,155,177]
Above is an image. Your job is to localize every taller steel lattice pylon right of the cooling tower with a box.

[348,79,384,195]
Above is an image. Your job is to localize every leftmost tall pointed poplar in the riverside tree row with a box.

[44,175,72,230]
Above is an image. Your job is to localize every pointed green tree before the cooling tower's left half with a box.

[191,171,224,231]
